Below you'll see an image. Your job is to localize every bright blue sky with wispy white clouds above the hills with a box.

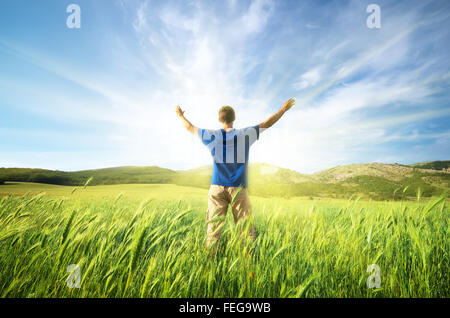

[0,0,450,173]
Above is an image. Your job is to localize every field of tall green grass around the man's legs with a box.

[0,182,450,297]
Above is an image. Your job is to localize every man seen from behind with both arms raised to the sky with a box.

[175,98,295,253]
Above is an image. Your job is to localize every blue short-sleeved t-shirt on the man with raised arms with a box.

[198,126,259,187]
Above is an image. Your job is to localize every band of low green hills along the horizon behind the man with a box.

[0,161,450,200]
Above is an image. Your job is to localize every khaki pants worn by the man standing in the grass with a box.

[206,184,256,249]
